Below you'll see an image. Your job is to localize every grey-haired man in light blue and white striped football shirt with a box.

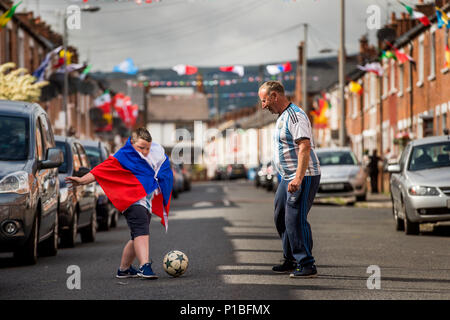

[258,81,320,278]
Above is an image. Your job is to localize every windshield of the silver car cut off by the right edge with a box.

[408,141,450,171]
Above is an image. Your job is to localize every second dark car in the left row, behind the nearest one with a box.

[55,136,97,247]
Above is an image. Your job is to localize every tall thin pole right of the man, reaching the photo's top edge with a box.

[339,0,347,147]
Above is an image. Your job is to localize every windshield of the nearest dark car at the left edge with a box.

[0,116,30,160]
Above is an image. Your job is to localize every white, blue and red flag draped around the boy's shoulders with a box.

[91,138,173,231]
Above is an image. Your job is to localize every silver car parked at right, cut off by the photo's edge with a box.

[388,136,450,234]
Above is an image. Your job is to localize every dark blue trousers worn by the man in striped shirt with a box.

[274,175,320,267]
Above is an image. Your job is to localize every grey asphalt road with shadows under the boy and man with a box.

[0,181,450,300]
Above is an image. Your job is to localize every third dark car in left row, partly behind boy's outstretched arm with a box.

[81,140,120,231]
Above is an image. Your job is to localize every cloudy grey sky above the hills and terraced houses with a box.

[15,0,417,72]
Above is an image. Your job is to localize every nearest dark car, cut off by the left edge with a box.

[0,100,62,264]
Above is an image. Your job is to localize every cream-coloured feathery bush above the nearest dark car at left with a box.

[0,62,48,102]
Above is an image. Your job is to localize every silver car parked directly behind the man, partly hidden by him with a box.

[316,148,367,201]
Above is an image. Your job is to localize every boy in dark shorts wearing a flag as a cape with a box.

[66,128,173,279]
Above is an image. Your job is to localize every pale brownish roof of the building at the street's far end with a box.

[148,93,208,122]
